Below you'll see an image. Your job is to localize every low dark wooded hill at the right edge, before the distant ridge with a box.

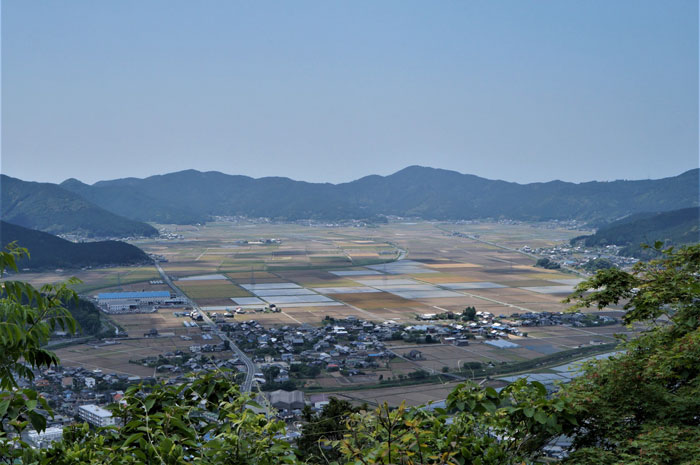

[571,207,700,258]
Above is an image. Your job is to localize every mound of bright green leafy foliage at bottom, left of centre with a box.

[44,372,296,465]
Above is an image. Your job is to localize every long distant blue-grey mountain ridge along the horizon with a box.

[61,166,700,223]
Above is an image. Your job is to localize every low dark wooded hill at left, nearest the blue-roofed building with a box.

[0,221,150,270]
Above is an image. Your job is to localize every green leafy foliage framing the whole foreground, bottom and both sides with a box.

[0,241,700,465]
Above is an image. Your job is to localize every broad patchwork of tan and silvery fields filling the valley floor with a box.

[98,222,600,324]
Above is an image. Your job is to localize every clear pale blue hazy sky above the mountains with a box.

[1,0,698,182]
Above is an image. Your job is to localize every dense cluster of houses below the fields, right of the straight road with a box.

[220,311,536,389]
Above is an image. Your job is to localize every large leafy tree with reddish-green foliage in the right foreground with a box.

[559,244,700,465]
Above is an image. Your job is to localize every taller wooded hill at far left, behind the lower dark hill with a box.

[0,175,158,237]
